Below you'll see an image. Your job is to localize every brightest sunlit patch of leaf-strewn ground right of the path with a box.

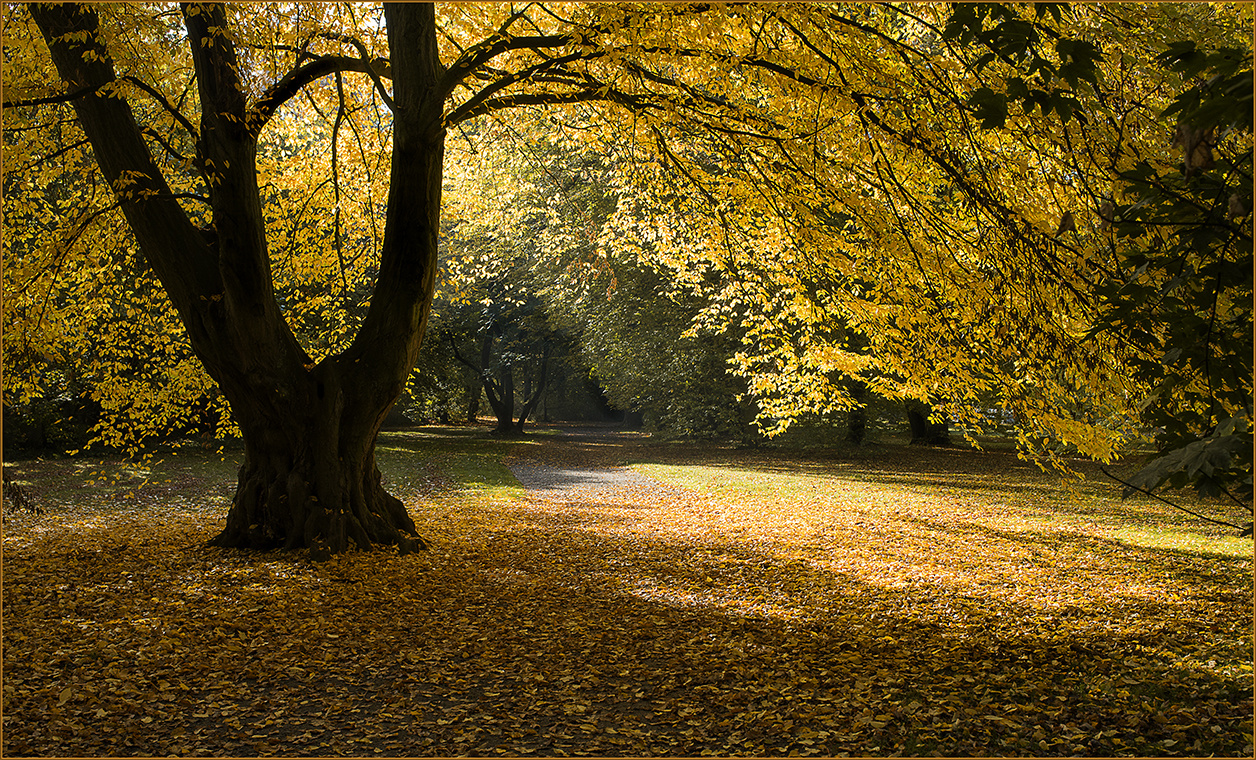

[633,464,1251,619]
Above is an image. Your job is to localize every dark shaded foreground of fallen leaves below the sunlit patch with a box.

[5,497,1250,755]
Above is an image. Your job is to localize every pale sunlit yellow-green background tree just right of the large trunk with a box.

[433,120,754,437]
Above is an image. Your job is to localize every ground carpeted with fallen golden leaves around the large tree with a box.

[4,431,1252,756]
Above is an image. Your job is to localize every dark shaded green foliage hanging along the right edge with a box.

[1100,43,1252,504]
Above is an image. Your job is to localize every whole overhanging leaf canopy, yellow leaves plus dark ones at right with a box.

[4,4,1251,500]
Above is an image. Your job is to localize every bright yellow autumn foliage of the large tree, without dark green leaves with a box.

[3,4,1250,467]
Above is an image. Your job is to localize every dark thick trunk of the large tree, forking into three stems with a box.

[31,4,445,556]
